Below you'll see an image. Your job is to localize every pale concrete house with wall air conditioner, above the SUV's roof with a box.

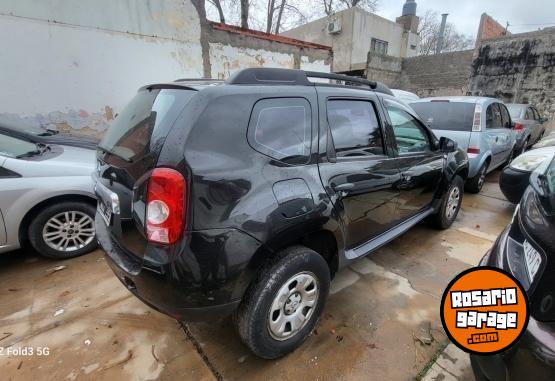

[282,7,419,72]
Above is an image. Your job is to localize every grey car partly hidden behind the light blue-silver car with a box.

[507,103,547,154]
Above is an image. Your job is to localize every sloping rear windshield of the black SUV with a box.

[99,89,196,161]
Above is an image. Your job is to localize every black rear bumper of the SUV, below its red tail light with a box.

[95,213,260,321]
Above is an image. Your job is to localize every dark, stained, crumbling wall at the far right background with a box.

[470,28,555,125]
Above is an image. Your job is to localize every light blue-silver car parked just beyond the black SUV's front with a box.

[410,97,516,193]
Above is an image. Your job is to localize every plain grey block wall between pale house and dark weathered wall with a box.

[397,50,474,97]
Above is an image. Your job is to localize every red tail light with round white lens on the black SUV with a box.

[146,168,187,244]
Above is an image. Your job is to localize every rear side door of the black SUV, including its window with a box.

[318,87,401,249]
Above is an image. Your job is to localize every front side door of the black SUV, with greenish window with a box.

[384,99,445,222]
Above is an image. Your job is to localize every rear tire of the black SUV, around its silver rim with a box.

[234,246,330,359]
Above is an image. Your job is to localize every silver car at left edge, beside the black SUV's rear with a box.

[0,132,97,259]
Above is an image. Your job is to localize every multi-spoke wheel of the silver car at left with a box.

[28,201,97,259]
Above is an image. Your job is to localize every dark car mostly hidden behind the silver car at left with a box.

[0,119,98,150]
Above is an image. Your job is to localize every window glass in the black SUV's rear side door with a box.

[327,99,385,157]
